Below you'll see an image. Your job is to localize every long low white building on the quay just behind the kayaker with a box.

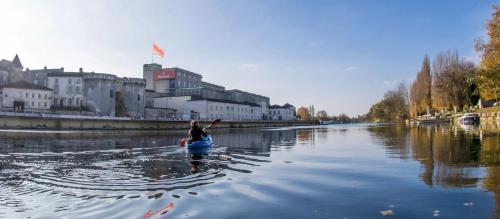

[182,99,262,121]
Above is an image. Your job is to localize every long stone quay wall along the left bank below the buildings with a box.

[0,115,317,130]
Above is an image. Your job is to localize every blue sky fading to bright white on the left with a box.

[0,0,500,116]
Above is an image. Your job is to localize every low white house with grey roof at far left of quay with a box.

[0,81,52,112]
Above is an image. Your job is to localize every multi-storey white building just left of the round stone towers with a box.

[47,72,84,108]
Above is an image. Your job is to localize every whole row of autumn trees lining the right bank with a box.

[366,5,500,122]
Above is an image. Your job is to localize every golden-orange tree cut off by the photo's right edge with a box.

[476,5,500,100]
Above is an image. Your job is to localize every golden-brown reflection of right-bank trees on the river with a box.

[368,124,500,217]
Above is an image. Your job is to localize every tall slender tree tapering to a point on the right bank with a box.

[410,55,432,117]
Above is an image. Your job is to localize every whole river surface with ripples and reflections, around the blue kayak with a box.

[0,125,500,219]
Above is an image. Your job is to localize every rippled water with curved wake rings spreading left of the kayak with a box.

[0,143,270,217]
